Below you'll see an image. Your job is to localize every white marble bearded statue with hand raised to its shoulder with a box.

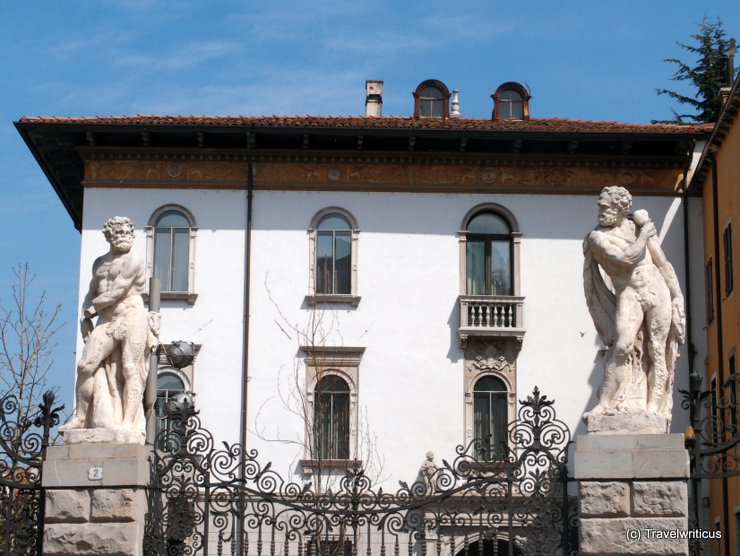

[583,186,686,426]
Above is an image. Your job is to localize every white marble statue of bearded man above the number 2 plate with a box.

[61,216,159,442]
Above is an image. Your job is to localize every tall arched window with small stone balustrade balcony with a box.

[458,203,524,345]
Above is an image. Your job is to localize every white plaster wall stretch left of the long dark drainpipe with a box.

[77,189,246,441]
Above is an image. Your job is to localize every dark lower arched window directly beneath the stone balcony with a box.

[473,375,509,461]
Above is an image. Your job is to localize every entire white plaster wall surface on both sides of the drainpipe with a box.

[78,189,706,487]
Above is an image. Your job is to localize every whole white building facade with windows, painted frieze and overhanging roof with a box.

[17,82,706,488]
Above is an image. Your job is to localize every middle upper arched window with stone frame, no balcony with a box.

[307,207,360,306]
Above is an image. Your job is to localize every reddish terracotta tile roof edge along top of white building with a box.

[19,114,712,134]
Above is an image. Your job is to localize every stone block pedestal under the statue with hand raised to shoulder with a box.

[574,432,689,556]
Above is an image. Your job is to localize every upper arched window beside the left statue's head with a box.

[147,205,197,303]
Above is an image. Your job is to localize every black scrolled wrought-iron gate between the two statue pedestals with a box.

[145,388,577,556]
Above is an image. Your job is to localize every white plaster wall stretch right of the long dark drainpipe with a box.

[249,192,687,484]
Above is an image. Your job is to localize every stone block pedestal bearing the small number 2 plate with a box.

[43,444,150,556]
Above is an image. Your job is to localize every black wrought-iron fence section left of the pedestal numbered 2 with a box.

[0,391,63,556]
